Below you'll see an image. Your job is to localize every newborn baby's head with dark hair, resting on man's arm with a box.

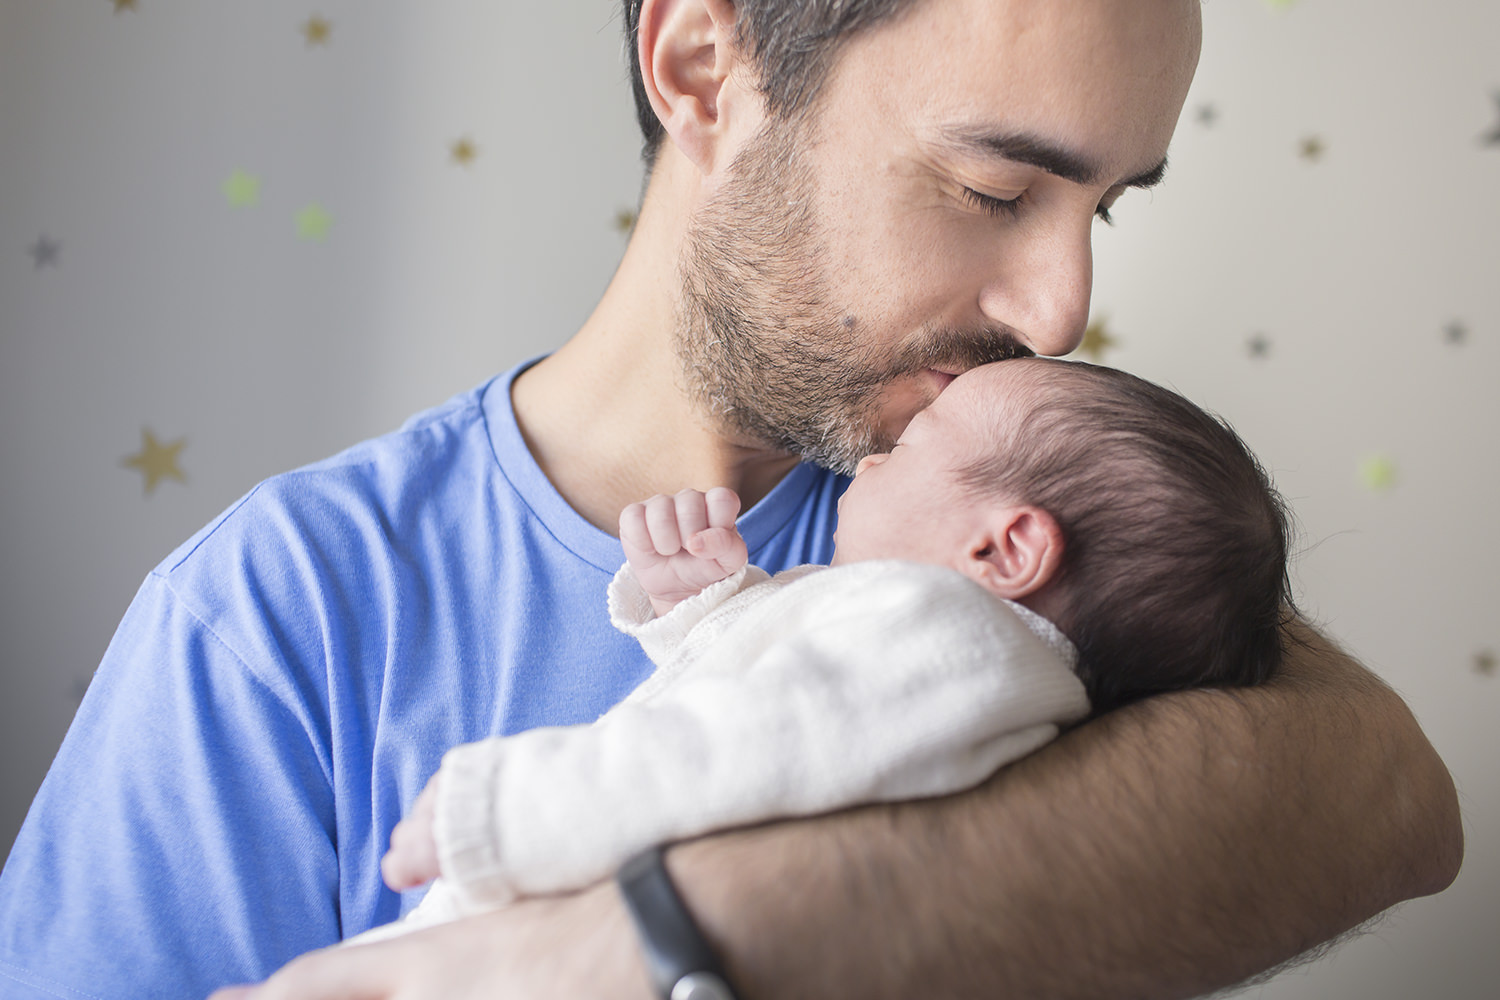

[834,358,1290,712]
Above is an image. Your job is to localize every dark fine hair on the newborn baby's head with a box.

[965,358,1293,714]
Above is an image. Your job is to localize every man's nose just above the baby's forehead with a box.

[980,217,1094,355]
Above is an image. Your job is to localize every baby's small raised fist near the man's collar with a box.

[620,486,750,615]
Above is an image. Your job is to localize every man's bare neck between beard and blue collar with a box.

[512,166,797,534]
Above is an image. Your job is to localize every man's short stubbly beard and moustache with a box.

[675,120,1031,475]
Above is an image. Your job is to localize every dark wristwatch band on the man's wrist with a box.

[615,847,737,1000]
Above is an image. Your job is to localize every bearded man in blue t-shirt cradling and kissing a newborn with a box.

[0,0,1461,999]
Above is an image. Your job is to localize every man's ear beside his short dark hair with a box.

[636,0,740,174]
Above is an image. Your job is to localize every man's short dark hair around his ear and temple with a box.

[624,0,917,166]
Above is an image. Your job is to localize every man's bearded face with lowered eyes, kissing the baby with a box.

[678,0,1200,472]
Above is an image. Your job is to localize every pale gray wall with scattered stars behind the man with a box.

[0,0,1500,1000]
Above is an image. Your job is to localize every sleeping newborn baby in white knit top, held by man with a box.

[354,358,1290,942]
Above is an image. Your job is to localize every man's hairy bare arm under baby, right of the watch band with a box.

[669,627,1463,1000]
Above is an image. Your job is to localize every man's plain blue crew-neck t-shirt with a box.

[0,369,848,1000]
